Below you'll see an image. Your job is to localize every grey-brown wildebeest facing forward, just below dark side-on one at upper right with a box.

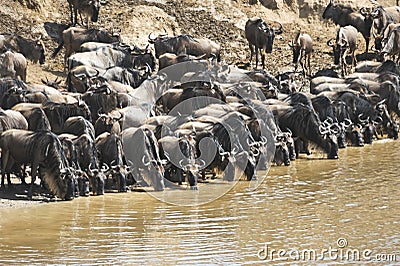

[327,25,357,75]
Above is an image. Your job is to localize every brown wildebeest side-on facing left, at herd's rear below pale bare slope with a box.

[148,34,221,61]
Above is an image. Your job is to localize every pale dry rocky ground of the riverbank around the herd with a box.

[0,0,395,208]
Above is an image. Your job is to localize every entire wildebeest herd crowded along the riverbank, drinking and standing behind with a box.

[0,0,400,200]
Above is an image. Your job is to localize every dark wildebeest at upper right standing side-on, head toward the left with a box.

[322,0,373,52]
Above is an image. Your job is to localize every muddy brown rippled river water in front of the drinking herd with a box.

[0,141,400,265]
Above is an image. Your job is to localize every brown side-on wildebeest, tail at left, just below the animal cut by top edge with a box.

[52,27,121,67]
